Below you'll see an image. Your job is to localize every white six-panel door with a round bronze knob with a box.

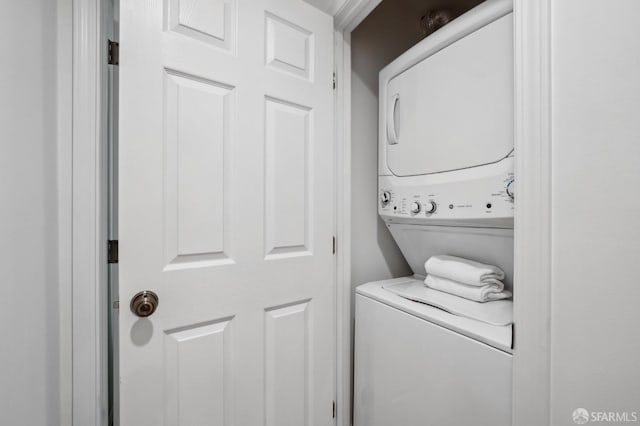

[119,0,335,426]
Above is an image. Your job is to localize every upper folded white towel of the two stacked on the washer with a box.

[424,255,504,286]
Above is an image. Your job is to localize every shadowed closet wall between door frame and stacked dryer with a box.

[351,1,420,288]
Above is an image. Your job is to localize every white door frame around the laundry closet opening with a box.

[335,0,551,426]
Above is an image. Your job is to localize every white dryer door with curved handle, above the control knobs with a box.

[381,13,514,176]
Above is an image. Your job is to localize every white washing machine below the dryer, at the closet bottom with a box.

[354,277,512,426]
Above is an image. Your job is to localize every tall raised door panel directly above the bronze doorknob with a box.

[164,70,234,269]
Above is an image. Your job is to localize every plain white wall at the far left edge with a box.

[0,0,61,426]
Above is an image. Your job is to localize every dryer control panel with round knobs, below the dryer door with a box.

[378,167,515,227]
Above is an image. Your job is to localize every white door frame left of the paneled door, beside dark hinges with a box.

[67,0,110,426]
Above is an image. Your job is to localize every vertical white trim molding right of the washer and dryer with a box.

[513,0,552,426]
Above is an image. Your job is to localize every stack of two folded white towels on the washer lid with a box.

[424,255,511,302]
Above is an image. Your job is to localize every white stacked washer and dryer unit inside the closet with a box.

[354,0,517,426]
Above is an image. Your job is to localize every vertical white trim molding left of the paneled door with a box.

[71,0,108,426]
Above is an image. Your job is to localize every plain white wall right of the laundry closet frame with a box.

[551,0,640,425]
